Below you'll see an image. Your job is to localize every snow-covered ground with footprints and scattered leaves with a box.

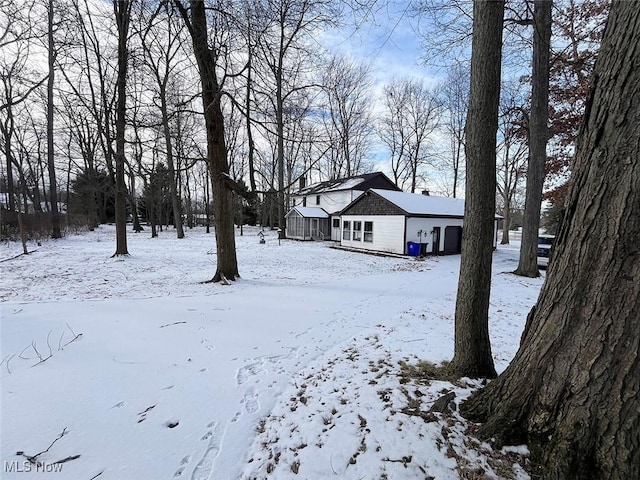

[0,226,543,480]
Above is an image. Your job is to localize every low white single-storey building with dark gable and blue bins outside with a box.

[340,189,502,255]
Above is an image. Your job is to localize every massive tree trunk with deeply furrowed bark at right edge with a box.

[462,1,640,479]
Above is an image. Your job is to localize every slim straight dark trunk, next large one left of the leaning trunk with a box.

[114,0,131,256]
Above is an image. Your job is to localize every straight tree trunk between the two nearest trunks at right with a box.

[515,0,553,277]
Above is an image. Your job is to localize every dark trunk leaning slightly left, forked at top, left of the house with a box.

[176,0,240,282]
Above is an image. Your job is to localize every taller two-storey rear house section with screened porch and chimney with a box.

[285,172,400,242]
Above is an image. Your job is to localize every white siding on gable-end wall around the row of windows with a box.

[340,215,405,255]
